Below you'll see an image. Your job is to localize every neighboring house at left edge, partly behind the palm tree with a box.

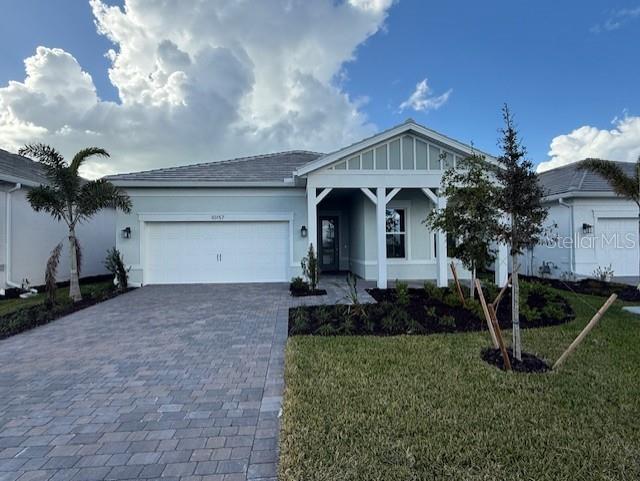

[0,149,115,294]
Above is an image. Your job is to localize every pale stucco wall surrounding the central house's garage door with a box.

[116,188,308,285]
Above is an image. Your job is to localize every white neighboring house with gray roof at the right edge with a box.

[520,162,638,280]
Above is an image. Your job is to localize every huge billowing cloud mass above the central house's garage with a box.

[0,0,393,176]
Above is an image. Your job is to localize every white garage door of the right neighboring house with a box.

[596,218,638,276]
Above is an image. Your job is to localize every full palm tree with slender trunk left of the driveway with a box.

[19,144,131,302]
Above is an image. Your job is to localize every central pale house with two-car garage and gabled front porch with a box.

[108,120,506,287]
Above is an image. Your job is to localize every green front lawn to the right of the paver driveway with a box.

[280,288,640,481]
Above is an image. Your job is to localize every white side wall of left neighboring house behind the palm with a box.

[0,188,115,287]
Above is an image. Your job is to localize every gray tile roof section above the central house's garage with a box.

[107,150,323,183]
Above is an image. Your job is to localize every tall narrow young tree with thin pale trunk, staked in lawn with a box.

[496,104,547,360]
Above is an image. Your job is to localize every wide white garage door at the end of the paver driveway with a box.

[145,222,289,284]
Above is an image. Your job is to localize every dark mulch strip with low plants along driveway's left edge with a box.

[0,289,132,339]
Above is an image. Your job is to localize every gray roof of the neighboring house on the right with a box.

[538,161,635,196]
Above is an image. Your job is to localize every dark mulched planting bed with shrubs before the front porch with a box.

[289,282,575,335]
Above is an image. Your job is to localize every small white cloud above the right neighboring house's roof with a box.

[538,115,640,172]
